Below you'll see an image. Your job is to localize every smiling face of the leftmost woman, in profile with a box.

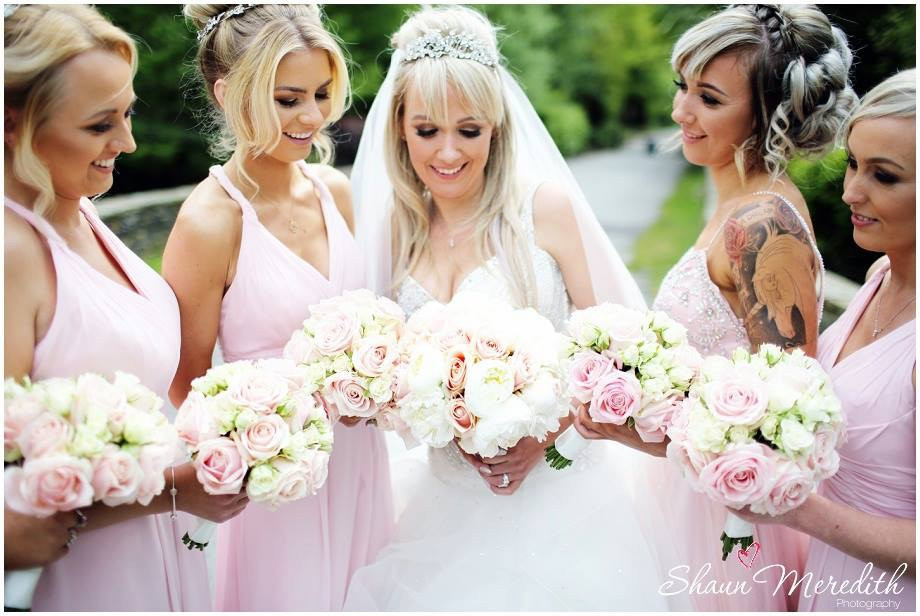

[33,49,136,201]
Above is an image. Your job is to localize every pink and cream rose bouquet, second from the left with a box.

[176,359,332,550]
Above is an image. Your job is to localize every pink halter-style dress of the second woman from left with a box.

[211,163,393,611]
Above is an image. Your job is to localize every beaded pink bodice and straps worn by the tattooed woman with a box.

[652,193,824,356]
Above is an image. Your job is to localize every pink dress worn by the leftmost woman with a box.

[5,198,211,612]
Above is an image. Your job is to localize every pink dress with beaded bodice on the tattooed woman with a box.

[645,193,824,611]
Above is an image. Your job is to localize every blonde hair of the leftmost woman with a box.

[3,4,137,216]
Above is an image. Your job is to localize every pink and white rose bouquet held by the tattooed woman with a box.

[546,304,702,469]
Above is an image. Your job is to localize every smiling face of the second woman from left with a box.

[269,49,332,163]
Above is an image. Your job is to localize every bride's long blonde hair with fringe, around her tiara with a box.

[384,6,535,306]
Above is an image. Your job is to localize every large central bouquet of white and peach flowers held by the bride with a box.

[395,293,568,458]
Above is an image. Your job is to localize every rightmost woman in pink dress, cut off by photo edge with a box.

[745,69,917,612]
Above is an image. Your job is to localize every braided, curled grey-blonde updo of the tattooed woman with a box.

[671,4,857,179]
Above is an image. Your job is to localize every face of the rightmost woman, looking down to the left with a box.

[843,117,917,252]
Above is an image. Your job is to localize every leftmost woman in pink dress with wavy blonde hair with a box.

[4,5,238,611]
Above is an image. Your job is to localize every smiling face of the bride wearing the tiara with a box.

[401,86,494,204]
